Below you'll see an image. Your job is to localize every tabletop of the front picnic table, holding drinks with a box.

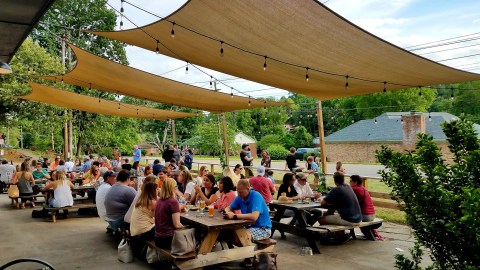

[180,209,255,230]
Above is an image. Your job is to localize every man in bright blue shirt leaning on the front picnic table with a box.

[224,179,272,241]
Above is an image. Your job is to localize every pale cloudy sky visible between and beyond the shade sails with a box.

[109,0,480,98]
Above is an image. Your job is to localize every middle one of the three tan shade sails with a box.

[39,44,285,112]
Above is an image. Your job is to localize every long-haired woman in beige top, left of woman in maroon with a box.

[130,181,158,241]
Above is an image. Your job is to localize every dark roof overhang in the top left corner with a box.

[0,0,55,62]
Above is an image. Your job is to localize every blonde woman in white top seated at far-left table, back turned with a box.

[45,171,75,207]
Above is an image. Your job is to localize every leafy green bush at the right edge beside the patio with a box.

[377,119,480,269]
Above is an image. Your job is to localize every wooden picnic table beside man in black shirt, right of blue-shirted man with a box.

[270,201,328,254]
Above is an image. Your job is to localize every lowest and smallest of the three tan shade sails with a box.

[19,82,196,120]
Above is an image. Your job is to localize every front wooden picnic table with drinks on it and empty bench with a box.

[176,210,255,270]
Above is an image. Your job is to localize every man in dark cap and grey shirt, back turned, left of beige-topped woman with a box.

[105,170,137,230]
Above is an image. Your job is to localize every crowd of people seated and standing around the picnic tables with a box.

[0,142,375,252]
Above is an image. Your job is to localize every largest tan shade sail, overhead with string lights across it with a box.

[89,0,480,100]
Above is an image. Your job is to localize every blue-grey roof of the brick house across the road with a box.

[325,112,480,143]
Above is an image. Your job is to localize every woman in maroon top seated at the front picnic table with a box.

[155,178,183,249]
